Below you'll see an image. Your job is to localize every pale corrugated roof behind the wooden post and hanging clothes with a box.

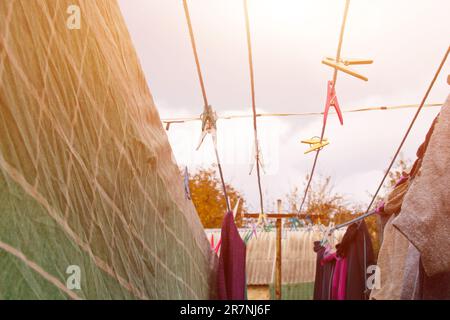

[205,226,345,285]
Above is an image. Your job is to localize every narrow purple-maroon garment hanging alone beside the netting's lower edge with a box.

[217,212,246,300]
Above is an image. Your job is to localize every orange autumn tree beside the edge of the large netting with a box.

[189,168,246,228]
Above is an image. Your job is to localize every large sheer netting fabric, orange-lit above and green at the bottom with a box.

[0,0,214,299]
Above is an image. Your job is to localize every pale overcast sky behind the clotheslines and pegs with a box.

[119,0,450,214]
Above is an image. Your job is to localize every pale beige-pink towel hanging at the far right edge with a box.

[393,96,450,277]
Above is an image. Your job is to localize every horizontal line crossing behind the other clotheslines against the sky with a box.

[161,103,443,124]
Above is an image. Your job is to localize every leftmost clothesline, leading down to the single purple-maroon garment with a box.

[183,0,231,212]
